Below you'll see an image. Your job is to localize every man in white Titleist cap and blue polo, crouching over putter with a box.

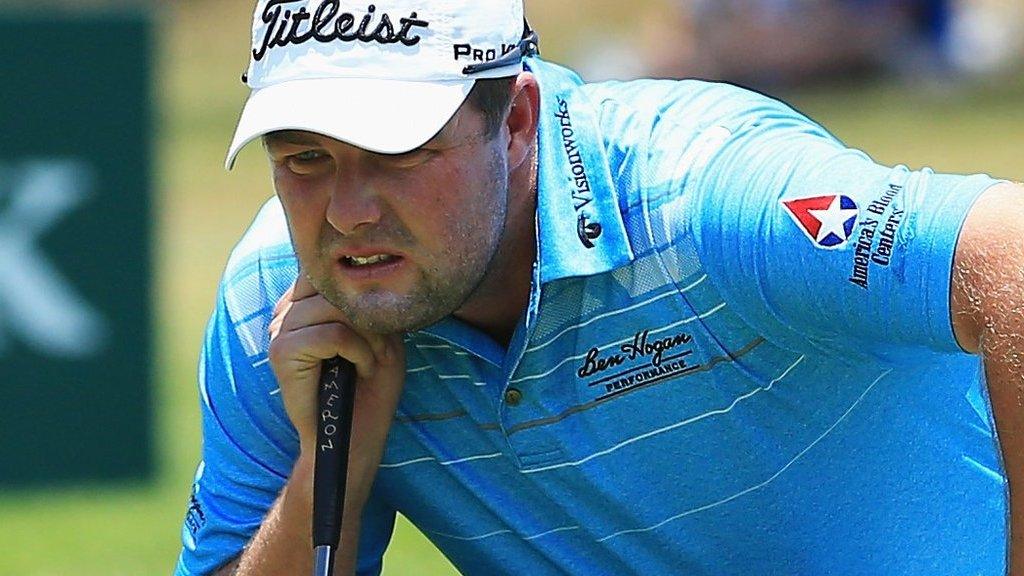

[177,0,1024,575]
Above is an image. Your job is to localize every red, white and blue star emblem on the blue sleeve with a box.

[781,195,860,250]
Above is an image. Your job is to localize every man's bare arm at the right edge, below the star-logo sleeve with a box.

[952,184,1024,576]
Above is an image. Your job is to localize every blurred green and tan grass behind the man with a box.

[0,0,1024,576]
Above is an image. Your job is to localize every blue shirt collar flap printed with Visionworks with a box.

[526,58,633,284]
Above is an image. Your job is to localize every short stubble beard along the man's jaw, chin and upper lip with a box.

[308,150,509,334]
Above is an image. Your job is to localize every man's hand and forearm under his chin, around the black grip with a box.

[218,273,406,576]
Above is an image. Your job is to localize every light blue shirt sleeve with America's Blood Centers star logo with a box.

[690,93,997,357]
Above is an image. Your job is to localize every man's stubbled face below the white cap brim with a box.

[265,105,508,333]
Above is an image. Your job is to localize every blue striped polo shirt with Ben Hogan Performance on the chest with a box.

[176,59,1009,576]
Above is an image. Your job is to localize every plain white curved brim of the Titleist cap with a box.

[225,78,473,170]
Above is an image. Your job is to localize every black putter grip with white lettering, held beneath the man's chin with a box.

[313,356,355,549]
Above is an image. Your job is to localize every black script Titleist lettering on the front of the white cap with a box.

[253,0,430,61]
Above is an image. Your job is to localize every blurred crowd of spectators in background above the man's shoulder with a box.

[583,0,1024,88]
